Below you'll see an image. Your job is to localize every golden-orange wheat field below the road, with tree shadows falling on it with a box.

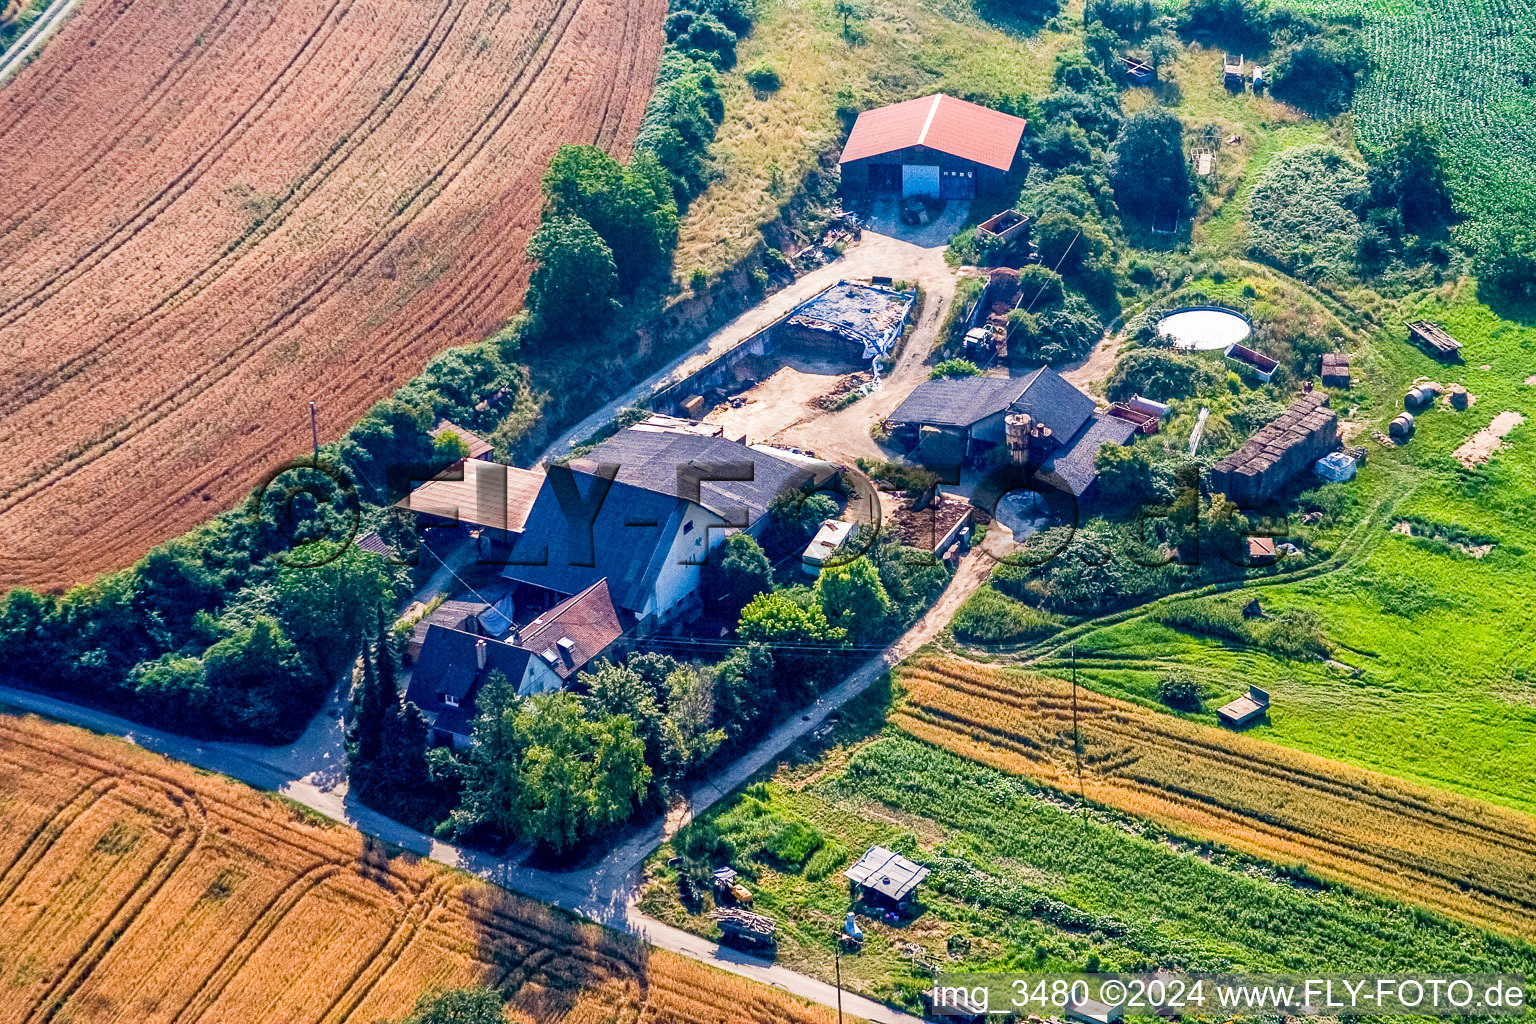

[0,715,833,1024]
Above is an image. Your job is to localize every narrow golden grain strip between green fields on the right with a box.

[892,659,1536,940]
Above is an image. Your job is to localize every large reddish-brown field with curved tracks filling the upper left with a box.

[0,0,667,588]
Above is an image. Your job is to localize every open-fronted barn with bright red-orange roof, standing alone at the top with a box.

[839,94,1025,200]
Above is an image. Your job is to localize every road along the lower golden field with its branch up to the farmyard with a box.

[0,548,992,1024]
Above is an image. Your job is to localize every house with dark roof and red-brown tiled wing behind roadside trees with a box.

[406,579,624,746]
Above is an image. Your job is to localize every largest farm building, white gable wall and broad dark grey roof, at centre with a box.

[502,430,837,631]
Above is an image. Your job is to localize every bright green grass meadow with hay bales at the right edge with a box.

[1019,277,1536,811]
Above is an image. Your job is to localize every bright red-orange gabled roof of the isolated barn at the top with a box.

[840,94,1025,170]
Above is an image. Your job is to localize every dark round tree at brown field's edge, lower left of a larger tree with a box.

[527,216,619,338]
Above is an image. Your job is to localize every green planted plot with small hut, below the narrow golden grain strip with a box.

[642,724,1536,1006]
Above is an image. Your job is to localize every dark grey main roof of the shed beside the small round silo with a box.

[889,367,1094,438]
